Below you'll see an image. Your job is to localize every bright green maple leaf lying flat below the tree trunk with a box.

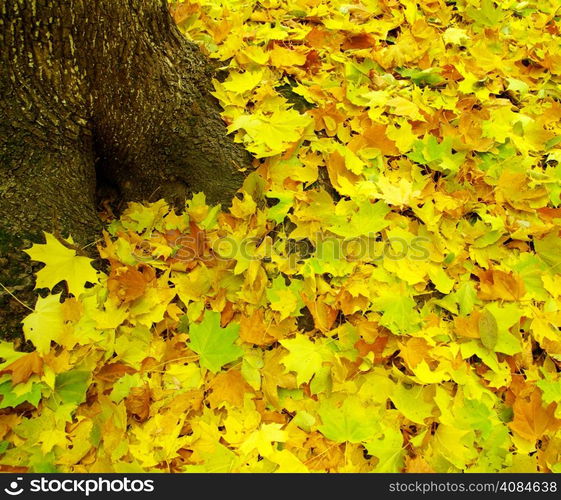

[187,311,243,373]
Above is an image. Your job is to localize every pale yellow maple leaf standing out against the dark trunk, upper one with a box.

[25,233,99,296]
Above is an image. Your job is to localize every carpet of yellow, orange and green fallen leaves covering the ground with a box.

[0,0,561,472]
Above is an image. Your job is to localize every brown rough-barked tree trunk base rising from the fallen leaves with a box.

[0,0,250,338]
